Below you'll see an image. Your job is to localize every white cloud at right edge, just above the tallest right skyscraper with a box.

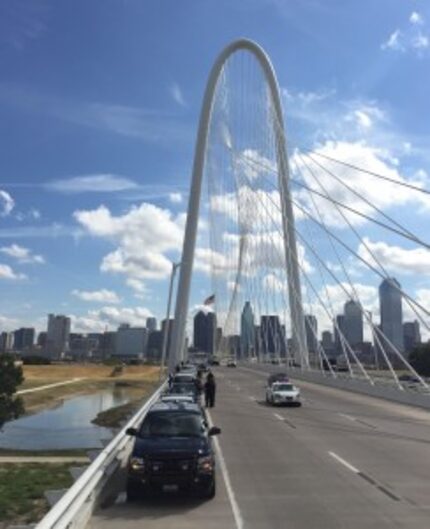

[358,237,430,276]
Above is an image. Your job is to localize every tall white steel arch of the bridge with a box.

[169,39,309,370]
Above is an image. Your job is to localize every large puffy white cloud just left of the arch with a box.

[74,202,183,280]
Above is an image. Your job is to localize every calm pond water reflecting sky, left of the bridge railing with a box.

[0,388,130,450]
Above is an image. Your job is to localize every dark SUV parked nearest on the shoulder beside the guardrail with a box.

[127,402,221,501]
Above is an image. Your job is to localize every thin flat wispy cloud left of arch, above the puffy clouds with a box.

[45,174,138,193]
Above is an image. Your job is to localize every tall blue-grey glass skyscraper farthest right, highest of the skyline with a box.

[379,277,404,355]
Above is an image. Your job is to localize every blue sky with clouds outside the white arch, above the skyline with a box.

[0,0,430,331]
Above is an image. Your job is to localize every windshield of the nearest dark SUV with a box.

[139,411,204,437]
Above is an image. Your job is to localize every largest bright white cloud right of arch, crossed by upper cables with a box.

[292,141,430,228]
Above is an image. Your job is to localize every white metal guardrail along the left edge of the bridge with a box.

[36,382,167,529]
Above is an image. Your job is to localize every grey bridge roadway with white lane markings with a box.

[90,368,430,529]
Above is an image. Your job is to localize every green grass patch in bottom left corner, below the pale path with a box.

[0,463,73,528]
